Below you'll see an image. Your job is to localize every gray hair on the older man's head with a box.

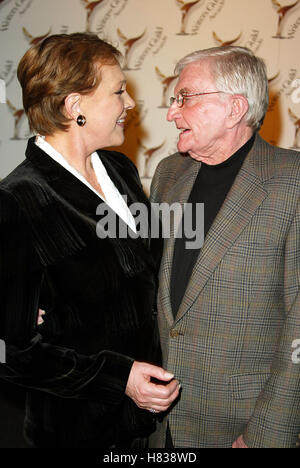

[175,46,269,131]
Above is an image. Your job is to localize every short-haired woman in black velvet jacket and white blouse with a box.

[0,33,179,448]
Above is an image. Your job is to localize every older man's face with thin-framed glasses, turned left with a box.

[167,59,230,164]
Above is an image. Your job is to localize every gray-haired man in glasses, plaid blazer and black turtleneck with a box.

[152,47,300,448]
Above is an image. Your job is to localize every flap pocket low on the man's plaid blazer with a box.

[229,372,270,400]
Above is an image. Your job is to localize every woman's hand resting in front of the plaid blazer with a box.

[125,361,180,413]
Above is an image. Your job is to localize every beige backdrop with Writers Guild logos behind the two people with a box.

[0,0,300,192]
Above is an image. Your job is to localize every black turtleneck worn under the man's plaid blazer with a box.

[171,135,255,317]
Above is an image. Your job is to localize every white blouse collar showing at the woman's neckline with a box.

[35,135,136,233]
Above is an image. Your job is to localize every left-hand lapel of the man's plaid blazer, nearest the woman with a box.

[158,159,201,326]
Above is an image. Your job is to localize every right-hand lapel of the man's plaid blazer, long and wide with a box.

[176,137,267,321]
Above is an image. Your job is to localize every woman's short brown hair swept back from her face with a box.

[18,33,121,135]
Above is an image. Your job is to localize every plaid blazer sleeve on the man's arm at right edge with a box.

[244,197,300,448]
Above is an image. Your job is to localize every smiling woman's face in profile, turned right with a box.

[80,65,135,151]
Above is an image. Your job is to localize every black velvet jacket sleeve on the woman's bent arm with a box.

[0,188,133,406]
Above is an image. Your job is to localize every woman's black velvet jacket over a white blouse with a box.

[0,138,160,447]
